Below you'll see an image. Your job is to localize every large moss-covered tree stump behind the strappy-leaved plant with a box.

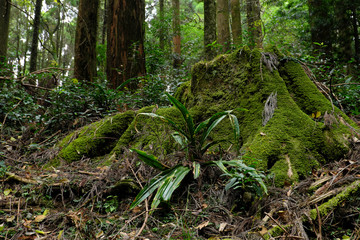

[53,48,357,186]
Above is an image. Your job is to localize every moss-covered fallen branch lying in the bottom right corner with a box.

[310,180,360,220]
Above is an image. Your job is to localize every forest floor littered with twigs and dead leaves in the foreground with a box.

[0,116,360,240]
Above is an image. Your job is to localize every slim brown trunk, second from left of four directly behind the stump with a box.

[216,0,231,52]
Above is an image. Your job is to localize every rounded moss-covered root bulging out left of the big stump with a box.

[58,111,135,162]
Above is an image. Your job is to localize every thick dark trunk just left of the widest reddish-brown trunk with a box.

[74,0,99,82]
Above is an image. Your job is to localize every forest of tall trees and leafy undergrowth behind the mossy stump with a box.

[0,0,360,238]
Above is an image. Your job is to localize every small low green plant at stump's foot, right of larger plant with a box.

[214,159,267,197]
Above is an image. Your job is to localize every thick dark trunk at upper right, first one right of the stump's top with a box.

[308,0,334,57]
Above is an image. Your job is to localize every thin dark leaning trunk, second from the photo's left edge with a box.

[30,0,42,72]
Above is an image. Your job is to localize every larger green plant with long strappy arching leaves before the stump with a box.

[130,93,244,209]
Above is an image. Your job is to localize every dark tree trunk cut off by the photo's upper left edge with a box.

[0,0,11,69]
